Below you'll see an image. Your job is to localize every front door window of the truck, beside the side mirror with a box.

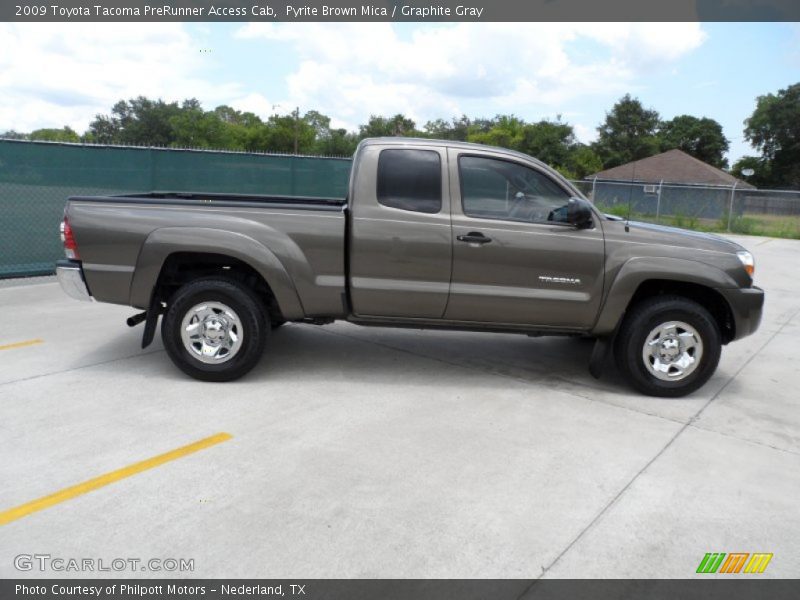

[458,156,570,223]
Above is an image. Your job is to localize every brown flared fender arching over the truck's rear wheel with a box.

[130,227,305,320]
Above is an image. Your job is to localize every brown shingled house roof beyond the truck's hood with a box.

[586,149,755,189]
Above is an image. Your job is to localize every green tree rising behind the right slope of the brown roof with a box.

[659,115,729,169]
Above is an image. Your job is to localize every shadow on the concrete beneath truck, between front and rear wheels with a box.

[247,323,632,397]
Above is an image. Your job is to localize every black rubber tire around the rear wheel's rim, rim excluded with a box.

[161,278,270,381]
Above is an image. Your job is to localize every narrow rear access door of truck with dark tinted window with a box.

[349,143,452,319]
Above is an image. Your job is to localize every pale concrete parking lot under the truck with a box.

[0,232,800,578]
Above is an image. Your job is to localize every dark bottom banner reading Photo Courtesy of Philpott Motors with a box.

[0,575,798,600]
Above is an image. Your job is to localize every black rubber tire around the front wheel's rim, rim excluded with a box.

[614,296,722,398]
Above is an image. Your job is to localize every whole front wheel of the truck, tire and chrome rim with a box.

[614,296,722,398]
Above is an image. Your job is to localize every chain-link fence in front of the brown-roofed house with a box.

[573,180,800,239]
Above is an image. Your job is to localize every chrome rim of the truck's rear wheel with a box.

[181,302,244,364]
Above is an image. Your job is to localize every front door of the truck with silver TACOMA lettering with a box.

[445,149,605,328]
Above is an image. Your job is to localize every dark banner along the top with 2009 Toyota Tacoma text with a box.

[0,0,800,22]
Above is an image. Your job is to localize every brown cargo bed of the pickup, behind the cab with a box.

[66,191,346,319]
